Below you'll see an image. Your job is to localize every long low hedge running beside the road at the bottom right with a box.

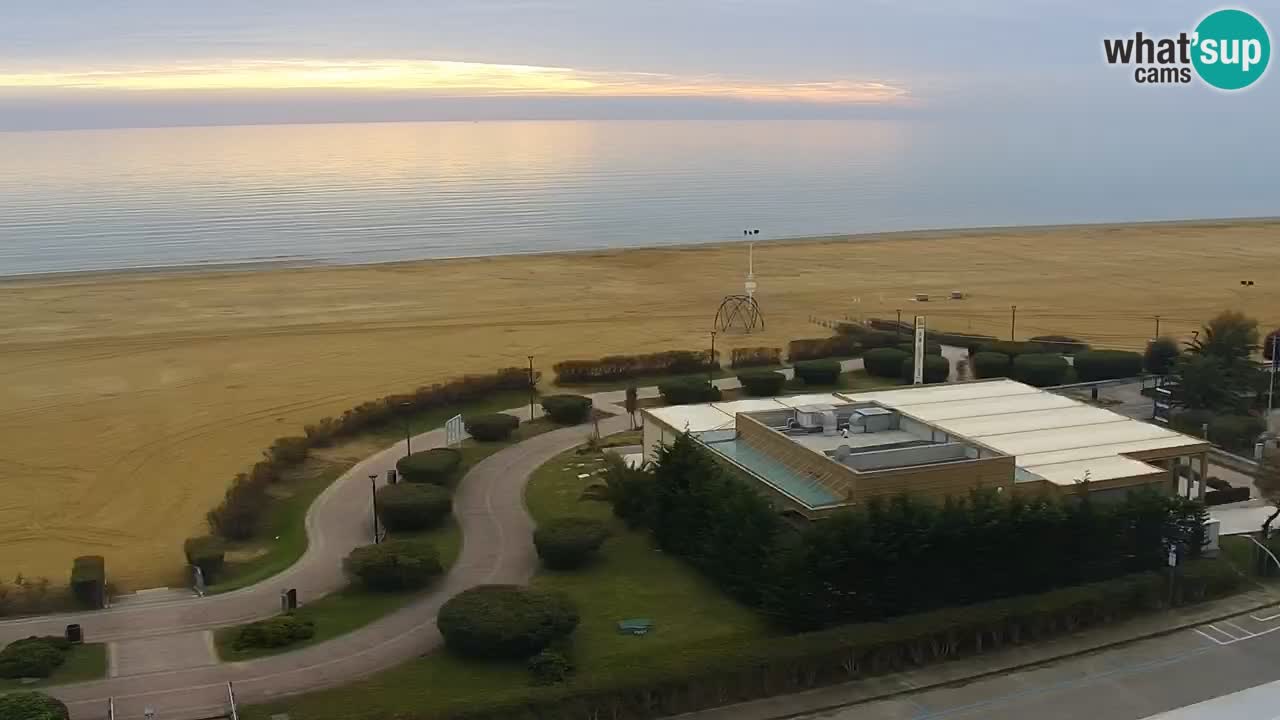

[427,560,1242,720]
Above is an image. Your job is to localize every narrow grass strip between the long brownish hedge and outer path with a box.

[209,392,529,593]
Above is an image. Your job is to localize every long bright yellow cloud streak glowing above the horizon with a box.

[0,59,910,104]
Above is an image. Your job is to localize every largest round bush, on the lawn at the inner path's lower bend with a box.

[435,585,577,660]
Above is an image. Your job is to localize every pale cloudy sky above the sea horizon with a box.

[0,0,1280,129]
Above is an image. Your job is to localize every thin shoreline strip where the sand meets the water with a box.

[0,215,1280,288]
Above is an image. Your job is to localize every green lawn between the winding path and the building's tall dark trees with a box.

[249,430,768,720]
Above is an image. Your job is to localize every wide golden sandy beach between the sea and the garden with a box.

[0,215,1280,588]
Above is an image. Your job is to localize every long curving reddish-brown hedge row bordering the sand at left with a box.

[206,368,539,541]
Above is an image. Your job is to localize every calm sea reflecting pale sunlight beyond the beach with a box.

[0,120,1280,275]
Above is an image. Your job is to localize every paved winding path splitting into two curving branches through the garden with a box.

[0,360,861,720]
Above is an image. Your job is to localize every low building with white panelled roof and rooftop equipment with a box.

[643,379,1210,518]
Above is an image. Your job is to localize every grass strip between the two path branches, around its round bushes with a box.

[214,419,559,661]
